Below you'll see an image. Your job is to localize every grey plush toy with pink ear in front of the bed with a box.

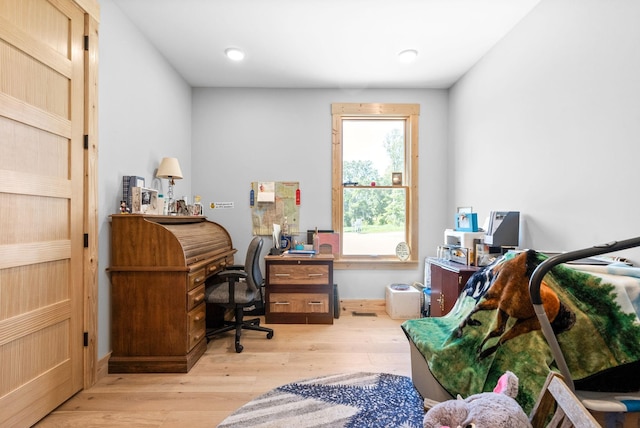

[424,371,531,428]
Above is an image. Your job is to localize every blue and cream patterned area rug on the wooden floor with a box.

[218,373,424,428]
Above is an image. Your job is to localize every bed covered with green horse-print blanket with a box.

[402,242,640,413]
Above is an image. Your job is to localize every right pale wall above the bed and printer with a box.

[449,0,640,262]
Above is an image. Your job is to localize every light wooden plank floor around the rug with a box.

[36,311,411,428]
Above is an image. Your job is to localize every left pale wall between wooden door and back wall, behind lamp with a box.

[98,0,191,358]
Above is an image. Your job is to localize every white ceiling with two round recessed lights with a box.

[112,0,540,89]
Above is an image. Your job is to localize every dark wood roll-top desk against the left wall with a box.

[108,214,236,373]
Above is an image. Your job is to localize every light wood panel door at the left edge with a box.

[0,0,85,426]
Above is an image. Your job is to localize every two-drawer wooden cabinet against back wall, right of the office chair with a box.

[265,254,334,324]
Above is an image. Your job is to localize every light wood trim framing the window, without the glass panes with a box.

[331,103,420,269]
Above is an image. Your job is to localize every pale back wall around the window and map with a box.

[191,88,451,299]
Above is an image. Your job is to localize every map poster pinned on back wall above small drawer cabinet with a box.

[251,181,300,236]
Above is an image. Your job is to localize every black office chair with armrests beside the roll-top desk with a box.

[205,236,273,352]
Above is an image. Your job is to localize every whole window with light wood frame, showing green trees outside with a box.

[332,104,420,268]
